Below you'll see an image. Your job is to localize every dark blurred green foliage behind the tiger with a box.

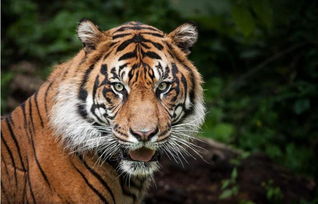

[1,0,318,201]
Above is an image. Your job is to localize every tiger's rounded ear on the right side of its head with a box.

[168,23,198,55]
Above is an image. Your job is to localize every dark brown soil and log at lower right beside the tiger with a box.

[146,140,315,204]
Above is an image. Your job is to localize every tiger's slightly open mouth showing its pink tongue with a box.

[121,147,161,162]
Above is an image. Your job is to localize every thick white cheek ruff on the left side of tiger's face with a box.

[50,83,106,151]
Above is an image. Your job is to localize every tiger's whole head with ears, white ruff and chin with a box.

[51,20,205,176]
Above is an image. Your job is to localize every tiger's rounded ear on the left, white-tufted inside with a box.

[77,19,103,53]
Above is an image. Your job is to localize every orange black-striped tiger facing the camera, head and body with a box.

[1,19,205,204]
